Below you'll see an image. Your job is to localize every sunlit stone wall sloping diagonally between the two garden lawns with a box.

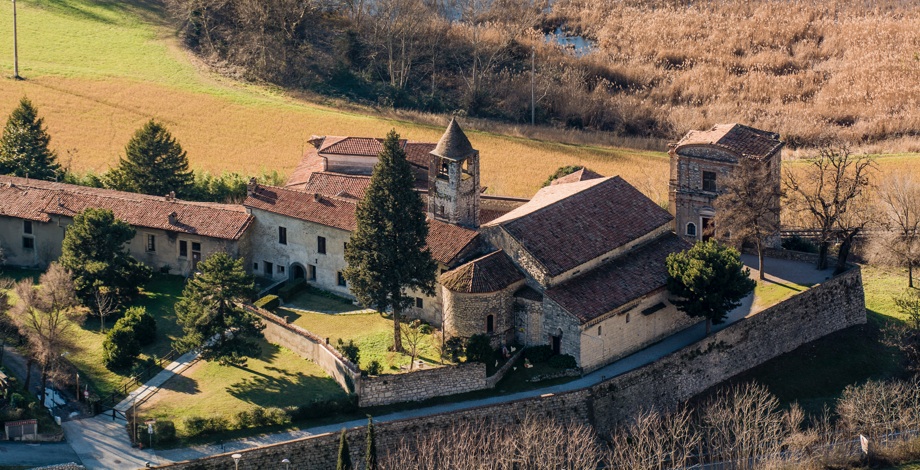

[246,305,361,393]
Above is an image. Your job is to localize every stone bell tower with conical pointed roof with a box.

[428,119,480,228]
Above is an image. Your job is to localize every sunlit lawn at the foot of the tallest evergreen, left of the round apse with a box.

[278,307,440,373]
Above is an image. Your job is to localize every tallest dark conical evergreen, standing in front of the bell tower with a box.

[343,130,437,351]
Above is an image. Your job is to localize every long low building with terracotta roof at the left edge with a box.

[0,176,253,275]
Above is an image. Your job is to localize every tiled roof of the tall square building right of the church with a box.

[675,124,783,159]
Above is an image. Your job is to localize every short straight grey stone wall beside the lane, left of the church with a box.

[358,362,489,408]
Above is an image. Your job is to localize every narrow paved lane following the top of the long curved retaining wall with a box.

[46,256,831,468]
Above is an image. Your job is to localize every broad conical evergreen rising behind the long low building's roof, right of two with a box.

[106,119,195,197]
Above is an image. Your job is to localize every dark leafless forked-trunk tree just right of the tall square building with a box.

[784,146,875,272]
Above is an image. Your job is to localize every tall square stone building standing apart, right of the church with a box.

[668,124,783,241]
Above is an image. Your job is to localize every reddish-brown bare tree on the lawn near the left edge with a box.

[12,263,85,402]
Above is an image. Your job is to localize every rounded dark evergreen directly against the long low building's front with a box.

[60,208,150,305]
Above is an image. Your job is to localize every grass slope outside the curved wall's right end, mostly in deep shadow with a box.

[731,266,907,413]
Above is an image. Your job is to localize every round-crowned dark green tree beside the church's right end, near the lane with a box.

[666,240,756,335]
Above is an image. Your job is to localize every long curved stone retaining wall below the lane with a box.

[161,267,866,470]
